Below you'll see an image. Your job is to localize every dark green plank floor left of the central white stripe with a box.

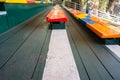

[0,9,51,80]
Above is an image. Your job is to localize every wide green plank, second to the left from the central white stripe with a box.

[0,9,48,80]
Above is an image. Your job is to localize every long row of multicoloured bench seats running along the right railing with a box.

[65,7,120,39]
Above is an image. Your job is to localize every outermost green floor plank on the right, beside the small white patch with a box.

[69,12,120,80]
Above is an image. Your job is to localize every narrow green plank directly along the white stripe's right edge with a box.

[67,26,89,80]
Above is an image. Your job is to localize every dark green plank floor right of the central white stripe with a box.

[67,9,120,80]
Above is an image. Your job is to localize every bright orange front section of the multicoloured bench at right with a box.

[86,23,120,38]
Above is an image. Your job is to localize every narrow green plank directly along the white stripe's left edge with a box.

[31,30,51,80]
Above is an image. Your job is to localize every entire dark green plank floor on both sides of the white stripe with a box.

[0,9,120,80]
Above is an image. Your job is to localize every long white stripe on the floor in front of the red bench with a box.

[42,30,80,80]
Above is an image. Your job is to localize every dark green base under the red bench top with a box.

[50,22,65,29]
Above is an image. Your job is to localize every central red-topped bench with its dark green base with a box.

[46,6,68,29]
